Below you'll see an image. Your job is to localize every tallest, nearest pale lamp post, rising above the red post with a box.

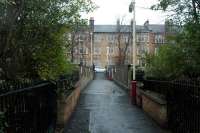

[129,0,136,80]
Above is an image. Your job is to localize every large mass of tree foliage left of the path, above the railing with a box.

[0,0,94,79]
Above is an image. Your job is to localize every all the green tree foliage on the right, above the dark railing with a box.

[146,0,200,79]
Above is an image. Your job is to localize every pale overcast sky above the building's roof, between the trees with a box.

[83,0,166,25]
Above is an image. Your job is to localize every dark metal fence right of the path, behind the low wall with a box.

[143,80,200,133]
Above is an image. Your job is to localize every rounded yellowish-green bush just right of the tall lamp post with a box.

[145,45,184,79]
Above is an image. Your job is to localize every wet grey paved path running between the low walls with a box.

[64,74,169,133]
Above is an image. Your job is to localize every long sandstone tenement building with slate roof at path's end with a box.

[71,19,165,67]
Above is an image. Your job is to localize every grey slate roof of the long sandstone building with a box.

[94,25,165,33]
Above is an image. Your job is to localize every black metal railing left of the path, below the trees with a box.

[0,82,57,133]
